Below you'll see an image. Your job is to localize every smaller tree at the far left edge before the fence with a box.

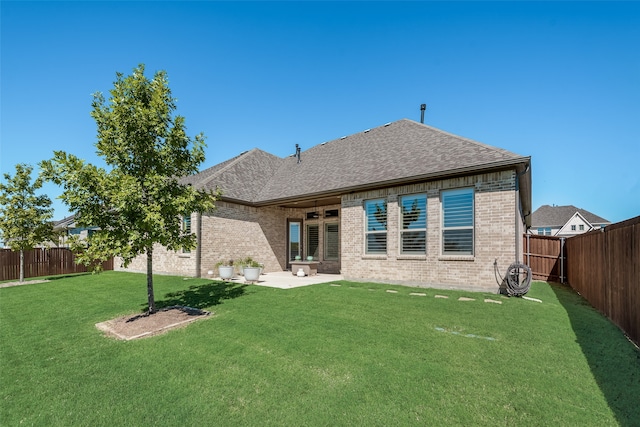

[0,163,54,282]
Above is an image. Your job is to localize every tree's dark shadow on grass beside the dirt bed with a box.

[145,282,246,310]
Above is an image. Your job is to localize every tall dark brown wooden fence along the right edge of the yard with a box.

[566,216,640,344]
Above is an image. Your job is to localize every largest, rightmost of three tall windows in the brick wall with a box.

[442,188,474,255]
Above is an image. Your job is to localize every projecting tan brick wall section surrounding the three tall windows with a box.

[341,171,521,291]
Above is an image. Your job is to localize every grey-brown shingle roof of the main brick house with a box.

[185,119,530,204]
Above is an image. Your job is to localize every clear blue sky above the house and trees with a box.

[0,0,640,222]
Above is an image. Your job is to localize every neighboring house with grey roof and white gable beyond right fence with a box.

[529,205,611,237]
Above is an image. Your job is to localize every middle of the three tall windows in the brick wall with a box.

[400,194,427,254]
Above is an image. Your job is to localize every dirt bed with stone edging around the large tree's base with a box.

[96,306,211,341]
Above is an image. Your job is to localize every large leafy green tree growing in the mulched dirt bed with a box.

[42,65,215,313]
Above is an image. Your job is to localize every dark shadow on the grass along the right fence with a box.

[551,283,640,426]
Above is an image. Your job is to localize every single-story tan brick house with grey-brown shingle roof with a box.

[117,119,531,291]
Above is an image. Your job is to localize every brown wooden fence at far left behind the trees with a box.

[0,248,113,281]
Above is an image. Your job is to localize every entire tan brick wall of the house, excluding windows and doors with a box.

[115,171,522,291]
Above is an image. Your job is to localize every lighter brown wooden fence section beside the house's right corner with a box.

[522,234,567,283]
